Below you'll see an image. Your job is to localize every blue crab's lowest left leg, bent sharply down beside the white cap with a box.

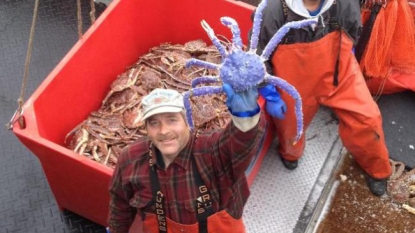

[183,86,223,129]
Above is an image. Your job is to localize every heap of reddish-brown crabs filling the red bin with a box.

[65,39,234,168]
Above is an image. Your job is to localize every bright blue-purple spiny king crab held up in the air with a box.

[183,0,317,142]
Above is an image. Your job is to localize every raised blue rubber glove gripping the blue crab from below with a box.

[223,83,261,117]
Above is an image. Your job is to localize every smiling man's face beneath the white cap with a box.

[146,113,190,161]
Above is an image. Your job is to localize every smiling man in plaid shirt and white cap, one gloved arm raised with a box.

[109,84,274,233]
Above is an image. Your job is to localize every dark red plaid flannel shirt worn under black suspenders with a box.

[109,113,266,233]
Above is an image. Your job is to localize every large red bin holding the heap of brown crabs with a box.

[13,0,272,226]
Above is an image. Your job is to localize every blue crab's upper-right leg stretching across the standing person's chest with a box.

[261,19,317,61]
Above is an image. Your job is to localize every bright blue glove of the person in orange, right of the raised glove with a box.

[258,84,287,119]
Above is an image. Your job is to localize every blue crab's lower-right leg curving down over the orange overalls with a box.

[265,75,304,145]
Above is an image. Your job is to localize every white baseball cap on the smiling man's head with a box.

[141,88,184,121]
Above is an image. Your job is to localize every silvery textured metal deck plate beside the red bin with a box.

[244,108,340,233]
